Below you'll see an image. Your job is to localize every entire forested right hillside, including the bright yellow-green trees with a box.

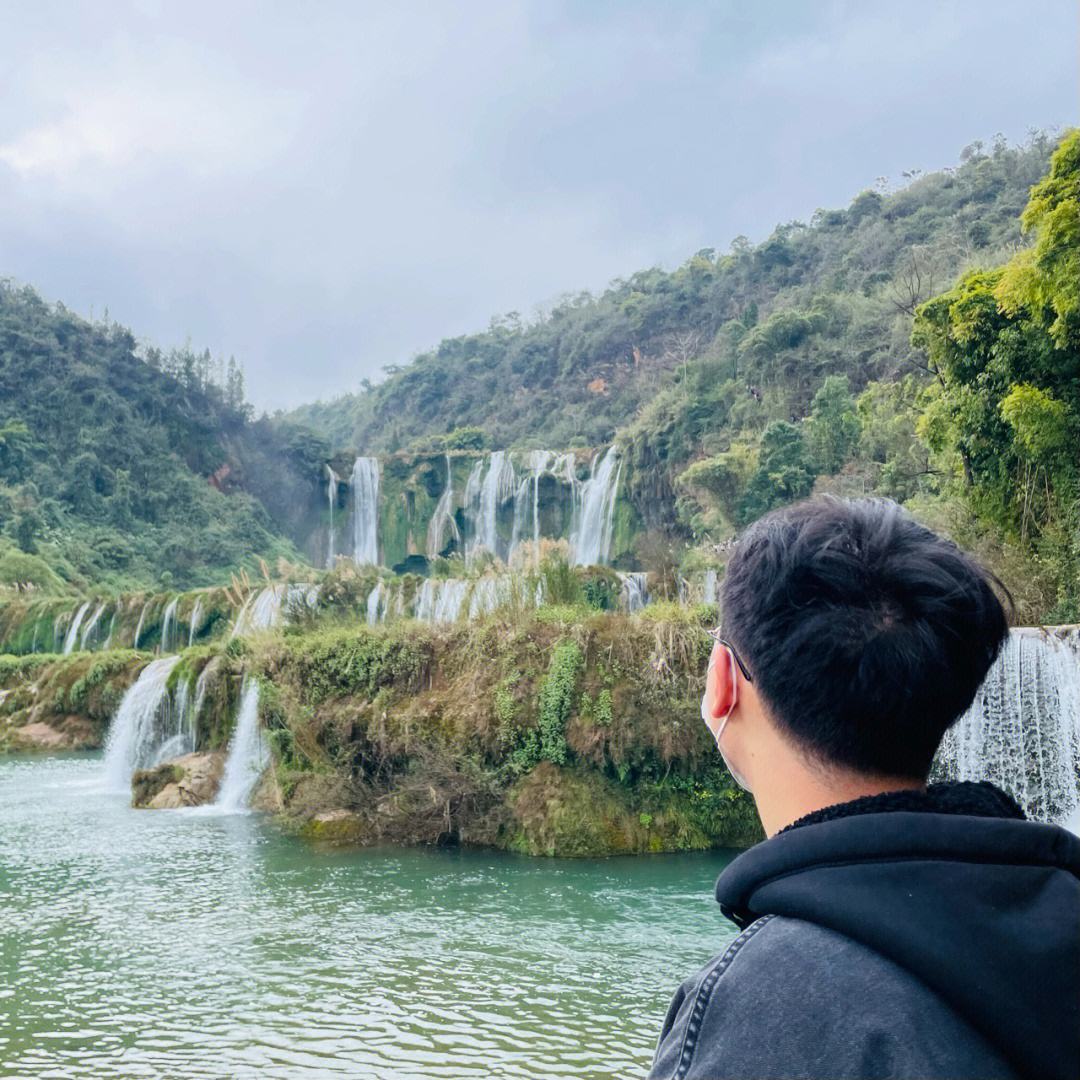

[292,134,1080,621]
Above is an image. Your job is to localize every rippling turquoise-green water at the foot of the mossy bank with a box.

[0,755,734,1080]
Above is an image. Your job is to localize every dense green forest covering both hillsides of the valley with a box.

[0,133,1080,621]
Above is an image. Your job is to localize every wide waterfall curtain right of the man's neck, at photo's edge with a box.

[934,630,1080,824]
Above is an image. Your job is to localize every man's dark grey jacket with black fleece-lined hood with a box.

[649,784,1080,1080]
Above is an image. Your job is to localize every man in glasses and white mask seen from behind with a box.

[650,499,1080,1080]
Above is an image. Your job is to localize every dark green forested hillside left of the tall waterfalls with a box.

[0,283,326,591]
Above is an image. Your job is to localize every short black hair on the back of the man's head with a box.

[721,497,1009,780]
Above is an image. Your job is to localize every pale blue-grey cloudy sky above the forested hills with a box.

[0,0,1080,409]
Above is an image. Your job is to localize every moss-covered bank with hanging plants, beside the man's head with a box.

[247,606,760,855]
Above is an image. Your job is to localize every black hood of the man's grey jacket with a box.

[716,784,1080,1080]
